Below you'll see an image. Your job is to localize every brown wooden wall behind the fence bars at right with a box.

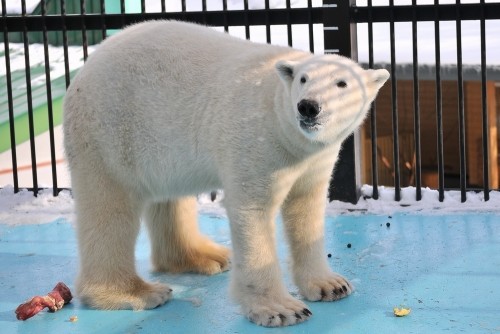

[362,80,500,188]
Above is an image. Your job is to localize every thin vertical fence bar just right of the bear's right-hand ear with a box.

[389,0,401,201]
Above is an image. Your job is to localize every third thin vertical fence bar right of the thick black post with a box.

[411,0,422,201]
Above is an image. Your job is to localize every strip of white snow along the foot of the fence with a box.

[0,185,500,225]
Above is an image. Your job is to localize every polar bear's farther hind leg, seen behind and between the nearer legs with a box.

[145,197,229,275]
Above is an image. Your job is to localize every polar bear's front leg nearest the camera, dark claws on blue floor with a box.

[226,196,312,327]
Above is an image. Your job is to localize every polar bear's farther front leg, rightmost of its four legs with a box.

[282,180,354,301]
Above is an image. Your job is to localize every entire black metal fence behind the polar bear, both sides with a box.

[0,0,500,202]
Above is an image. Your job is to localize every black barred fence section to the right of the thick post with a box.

[351,0,500,202]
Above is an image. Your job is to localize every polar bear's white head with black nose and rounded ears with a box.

[275,55,389,144]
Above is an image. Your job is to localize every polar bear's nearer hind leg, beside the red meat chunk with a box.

[72,170,172,310]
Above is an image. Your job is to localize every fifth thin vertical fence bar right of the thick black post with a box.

[456,0,467,203]
